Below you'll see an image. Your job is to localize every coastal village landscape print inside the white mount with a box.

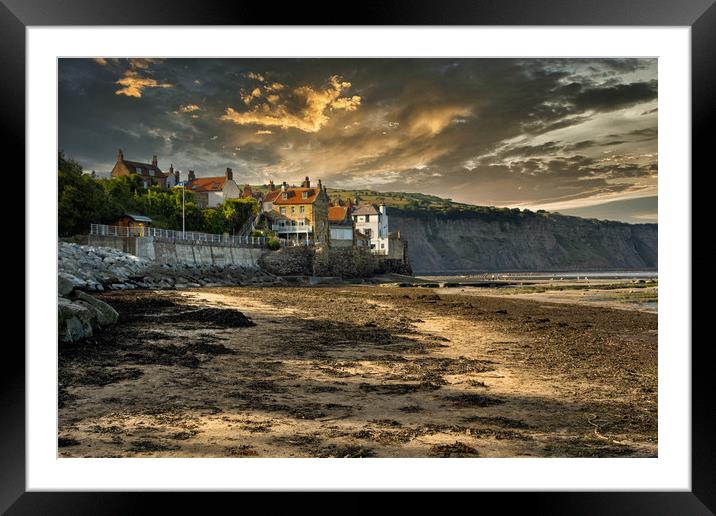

[57,57,658,459]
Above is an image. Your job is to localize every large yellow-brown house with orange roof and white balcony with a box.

[272,177,329,244]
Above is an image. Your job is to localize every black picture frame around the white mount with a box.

[0,0,716,514]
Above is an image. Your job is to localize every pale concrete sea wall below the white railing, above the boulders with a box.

[89,235,266,268]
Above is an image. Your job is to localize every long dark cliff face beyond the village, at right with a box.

[389,210,657,273]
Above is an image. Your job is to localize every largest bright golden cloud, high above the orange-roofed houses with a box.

[220,75,361,133]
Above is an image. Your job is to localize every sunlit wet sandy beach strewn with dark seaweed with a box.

[58,286,657,457]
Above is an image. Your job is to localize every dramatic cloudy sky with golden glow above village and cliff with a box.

[58,58,658,222]
